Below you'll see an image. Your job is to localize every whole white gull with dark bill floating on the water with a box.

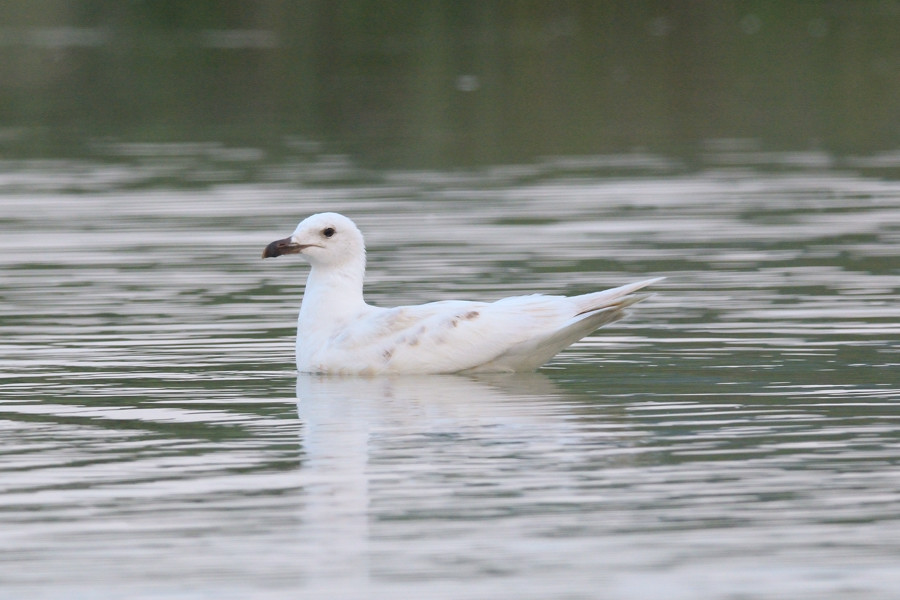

[263,212,664,375]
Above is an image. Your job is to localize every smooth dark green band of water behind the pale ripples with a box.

[0,0,900,169]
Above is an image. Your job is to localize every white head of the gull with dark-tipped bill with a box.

[263,213,366,266]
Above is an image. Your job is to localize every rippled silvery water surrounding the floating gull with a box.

[0,163,900,600]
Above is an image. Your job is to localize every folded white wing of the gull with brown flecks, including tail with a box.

[316,279,659,373]
